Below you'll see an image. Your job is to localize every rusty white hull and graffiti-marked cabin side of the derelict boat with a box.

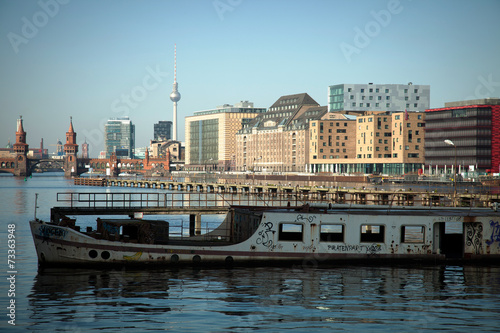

[30,205,500,266]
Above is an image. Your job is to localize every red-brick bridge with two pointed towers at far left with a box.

[0,117,170,177]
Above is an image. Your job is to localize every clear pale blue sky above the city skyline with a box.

[0,0,500,157]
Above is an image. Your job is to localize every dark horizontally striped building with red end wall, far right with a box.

[425,98,500,173]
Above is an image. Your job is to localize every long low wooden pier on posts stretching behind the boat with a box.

[74,177,500,207]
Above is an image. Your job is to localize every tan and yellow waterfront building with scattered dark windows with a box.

[308,112,425,175]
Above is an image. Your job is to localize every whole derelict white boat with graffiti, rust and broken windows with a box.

[30,201,500,266]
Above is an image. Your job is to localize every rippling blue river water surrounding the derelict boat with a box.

[0,173,500,332]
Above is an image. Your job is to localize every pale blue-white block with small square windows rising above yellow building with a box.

[328,82,430,113]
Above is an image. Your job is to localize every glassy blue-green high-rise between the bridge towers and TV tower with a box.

[104,117,135,158]
